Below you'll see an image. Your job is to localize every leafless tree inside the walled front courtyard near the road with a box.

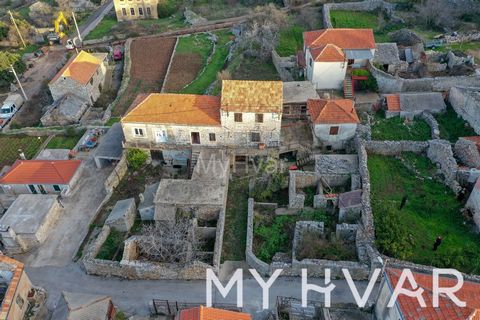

[138,219,202,263]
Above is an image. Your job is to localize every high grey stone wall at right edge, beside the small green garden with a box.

[448,83,480,134]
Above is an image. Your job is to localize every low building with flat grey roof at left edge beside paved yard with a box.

[0,194,61,254]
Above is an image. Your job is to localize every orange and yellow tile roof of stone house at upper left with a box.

[50,50,103,85]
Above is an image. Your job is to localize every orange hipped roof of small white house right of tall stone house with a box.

[307,99,360,124]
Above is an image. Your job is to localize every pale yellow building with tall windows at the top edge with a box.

[113,0,158,21]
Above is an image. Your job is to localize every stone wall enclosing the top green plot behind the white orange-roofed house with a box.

[322,0,399,28]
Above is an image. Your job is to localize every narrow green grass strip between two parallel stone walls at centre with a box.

[222,178,248,261]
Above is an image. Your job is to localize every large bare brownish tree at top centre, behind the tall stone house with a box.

[235,4,287,60]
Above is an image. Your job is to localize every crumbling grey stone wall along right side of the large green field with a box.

[427,140,462,194]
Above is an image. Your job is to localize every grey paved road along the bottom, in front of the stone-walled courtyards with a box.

[27,264,377,315]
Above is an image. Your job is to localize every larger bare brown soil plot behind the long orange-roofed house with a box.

[112,37,176,116]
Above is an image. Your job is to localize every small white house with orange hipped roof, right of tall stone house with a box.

[307,99,360,150]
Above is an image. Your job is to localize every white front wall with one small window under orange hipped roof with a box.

[313,123,357,149]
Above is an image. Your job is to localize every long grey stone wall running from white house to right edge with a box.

[368,64,480,93]
